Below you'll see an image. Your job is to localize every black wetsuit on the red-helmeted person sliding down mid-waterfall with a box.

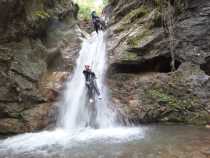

[83,70,100,95]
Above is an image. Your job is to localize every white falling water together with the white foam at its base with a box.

[0,32,143,158]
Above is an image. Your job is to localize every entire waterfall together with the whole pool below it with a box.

[0,32,210,158]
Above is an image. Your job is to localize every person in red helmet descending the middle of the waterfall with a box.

[83,65,101,99]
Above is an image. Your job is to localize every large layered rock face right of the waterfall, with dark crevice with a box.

[105,0,210,124]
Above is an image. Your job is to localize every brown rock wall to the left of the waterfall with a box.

[0,0,80,134]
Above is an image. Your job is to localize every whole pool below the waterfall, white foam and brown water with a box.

[0,125,210,158]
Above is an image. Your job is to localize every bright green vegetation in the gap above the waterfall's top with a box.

[74,0,108,20]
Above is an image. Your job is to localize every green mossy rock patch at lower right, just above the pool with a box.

[145,87,210,125]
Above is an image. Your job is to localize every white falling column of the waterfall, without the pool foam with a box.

[60,32,114,130]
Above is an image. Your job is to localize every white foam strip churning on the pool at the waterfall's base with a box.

[0,127,143,152]
